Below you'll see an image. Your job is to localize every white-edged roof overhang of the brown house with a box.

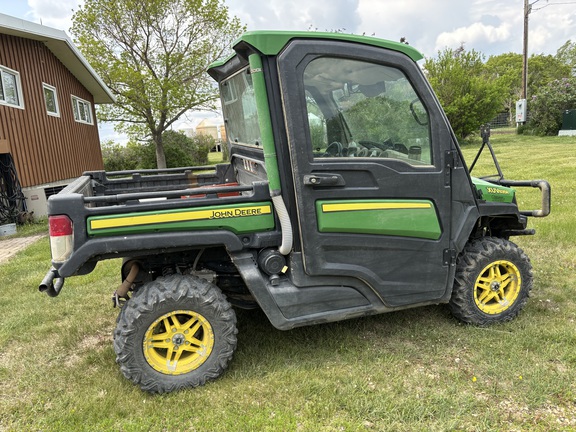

[0,13,115,103]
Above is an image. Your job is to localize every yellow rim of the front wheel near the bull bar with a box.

[474,261,522,315]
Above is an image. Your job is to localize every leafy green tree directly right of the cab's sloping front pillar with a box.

[424,47,503,138]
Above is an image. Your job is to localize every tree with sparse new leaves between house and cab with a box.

[72,0,244,168]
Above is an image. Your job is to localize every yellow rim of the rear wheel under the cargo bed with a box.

[144,310,214,375]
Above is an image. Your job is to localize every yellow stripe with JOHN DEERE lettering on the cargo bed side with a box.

[90,205,272,230]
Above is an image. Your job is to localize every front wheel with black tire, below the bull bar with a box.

[449,237,533,326]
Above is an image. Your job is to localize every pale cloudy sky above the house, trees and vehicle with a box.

[0,0,576,141]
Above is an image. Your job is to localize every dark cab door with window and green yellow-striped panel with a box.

[277,40,452,307]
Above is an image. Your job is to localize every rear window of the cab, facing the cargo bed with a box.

[220,68,261,147]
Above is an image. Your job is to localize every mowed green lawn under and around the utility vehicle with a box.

[0,134,576,431]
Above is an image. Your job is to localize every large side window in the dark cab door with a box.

[304,57,432,166]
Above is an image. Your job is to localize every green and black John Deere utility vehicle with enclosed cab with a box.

[40,31,550,392]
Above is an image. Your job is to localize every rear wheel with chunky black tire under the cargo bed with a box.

[114,275,237,393]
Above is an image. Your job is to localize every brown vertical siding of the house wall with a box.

[0,34,103,187]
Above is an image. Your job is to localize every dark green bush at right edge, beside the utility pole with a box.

[527,77,576,135]
